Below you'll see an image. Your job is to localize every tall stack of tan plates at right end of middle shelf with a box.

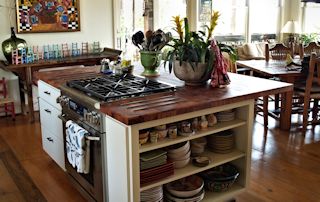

[207,130,235,154]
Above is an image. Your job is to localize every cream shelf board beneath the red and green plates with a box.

[140,149,246,191]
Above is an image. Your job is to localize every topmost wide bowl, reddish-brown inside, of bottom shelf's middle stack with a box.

[165,175,204,198]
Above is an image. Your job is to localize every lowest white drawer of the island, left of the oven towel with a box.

[41,125,65,170]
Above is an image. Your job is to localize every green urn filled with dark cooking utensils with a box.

[132,29,170,76]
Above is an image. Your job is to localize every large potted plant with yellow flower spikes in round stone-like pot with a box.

[164,12,237,86]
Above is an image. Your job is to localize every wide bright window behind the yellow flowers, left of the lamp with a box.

[198,0,281,43]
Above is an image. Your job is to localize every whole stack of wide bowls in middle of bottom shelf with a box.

[165,175,204,202]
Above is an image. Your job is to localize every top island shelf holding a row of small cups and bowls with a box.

[139,110,246,153]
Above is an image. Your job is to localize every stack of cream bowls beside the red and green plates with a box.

[168,141,191,168]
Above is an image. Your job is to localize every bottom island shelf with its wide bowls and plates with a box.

[140,163,244,202]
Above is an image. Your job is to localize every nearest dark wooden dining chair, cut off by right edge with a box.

[294,53,320,133]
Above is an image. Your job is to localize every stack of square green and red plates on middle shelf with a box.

[140,150,174,185]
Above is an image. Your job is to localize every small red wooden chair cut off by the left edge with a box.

[0,78,16,120]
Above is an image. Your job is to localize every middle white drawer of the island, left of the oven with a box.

[39,98,63,141]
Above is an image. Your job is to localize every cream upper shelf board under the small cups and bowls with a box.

[139,119,246,153]
